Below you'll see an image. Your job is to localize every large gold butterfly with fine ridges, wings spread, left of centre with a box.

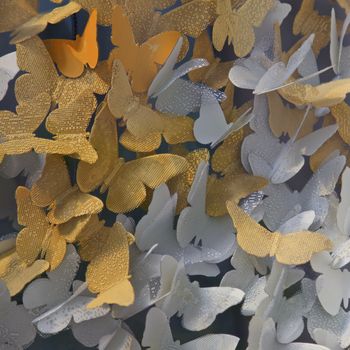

[77,103,188,213]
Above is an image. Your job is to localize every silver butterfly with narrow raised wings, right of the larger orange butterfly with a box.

[148,37,225,115]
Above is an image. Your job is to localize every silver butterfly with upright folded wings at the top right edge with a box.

[329,9,350,79]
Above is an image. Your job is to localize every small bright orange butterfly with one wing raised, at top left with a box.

[44,7,98,78]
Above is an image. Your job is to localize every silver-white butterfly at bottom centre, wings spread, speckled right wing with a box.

[156,256,244,331]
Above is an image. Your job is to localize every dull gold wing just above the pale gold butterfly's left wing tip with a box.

[206,174,268,216]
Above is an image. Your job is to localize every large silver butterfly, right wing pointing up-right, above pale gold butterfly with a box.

[241,96,338,184]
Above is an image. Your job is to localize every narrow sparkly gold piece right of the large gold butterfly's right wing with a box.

[168,148,209,214]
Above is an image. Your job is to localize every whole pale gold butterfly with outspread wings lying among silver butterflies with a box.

[226,201,332,265]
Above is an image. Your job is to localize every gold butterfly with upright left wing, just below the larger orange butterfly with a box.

[107,60,193,147]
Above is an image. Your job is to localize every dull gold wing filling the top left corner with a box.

[0,0,38,33]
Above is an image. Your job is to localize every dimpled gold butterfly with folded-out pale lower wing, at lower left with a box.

[86,223,135,308]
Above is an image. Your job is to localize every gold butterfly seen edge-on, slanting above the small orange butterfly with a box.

[9,1,81,44]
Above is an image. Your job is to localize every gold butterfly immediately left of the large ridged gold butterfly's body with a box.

[31,155,103,225]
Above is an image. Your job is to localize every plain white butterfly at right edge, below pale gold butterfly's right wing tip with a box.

[310,252,350,316]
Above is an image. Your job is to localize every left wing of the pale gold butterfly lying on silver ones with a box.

[226,202,275,257]
